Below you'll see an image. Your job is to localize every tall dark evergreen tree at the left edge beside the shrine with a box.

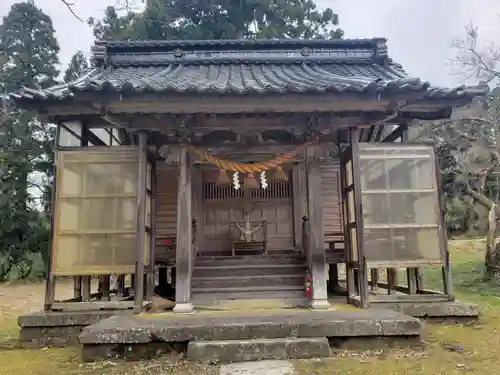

[0,1,59,279]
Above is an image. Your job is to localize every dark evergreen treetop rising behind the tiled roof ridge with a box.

[89,0,343,40]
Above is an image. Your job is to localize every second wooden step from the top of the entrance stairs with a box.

[193,264,307,278]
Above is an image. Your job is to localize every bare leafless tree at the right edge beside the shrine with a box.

[416,24,500,279]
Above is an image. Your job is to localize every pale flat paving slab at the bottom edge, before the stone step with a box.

[220,361,294,375]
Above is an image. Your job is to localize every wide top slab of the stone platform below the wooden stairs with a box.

[79,309,423,344]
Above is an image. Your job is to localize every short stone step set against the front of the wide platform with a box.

[187,337,330,363]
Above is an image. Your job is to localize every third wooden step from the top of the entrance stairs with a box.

[193,273,304,290]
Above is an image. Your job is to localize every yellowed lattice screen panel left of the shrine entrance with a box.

[52,148,143,276]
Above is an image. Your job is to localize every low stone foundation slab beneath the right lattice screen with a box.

[384,301,480,319]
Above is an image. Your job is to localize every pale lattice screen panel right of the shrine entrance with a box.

[360,145,443,264]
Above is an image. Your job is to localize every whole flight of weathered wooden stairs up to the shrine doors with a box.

[192,253,307,304]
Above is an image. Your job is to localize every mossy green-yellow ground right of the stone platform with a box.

[295,241,500,375]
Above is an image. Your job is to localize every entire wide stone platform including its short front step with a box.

[79,308,423,362]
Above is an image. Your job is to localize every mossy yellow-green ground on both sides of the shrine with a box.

[0,241,500,375]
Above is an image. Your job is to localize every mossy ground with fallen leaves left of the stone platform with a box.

[0,283,219,375]
